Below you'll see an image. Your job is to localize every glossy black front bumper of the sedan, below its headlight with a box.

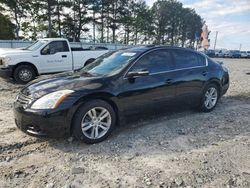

[14,102,71,137]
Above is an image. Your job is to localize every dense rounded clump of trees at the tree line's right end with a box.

[152,0,202,46]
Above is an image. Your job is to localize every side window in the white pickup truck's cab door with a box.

[41,41,69,55]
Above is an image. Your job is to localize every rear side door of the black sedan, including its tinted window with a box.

[172,49,208,102]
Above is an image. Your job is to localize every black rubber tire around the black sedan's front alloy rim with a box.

[72,99,116,144]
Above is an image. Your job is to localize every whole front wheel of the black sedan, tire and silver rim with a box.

[73,100,116,144]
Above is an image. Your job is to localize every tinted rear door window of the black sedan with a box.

[173,50,206,69]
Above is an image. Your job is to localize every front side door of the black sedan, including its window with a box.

[120,49,175,113]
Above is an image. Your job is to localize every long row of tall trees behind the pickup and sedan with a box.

[0,0,203,46]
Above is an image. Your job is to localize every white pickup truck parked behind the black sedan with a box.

[0,38,108,84]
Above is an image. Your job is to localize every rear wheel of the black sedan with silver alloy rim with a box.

[200,84,219,112]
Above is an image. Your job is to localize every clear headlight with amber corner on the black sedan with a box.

[31,90,74,109]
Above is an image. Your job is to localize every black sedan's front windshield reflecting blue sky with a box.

[80,50,140,75]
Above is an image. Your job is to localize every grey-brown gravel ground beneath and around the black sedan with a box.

[0,59,250,188]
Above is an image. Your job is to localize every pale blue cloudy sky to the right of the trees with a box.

[146,0,250,51]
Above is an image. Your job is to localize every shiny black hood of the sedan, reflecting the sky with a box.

[21,72,102,99]
